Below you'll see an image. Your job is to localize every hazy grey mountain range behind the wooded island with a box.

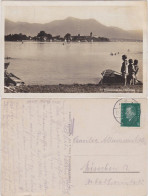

[5,17,143,40]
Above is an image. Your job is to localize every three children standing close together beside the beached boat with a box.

[121,55,139,86]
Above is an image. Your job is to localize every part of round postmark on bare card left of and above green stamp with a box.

[113,98,138,124]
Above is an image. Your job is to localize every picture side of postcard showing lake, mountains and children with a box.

[1,1,147,98]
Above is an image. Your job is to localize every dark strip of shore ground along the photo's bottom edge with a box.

[4,84,143,93]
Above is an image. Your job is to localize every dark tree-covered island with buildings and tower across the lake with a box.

[5,31,110,42]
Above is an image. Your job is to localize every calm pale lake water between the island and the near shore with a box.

[5,42,143,85]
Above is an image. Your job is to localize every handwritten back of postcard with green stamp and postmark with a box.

[1,99,148,196]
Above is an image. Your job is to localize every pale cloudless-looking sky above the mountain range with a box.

[5,6,144,30]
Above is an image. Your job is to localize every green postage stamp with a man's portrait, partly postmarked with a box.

[121,103,140,127]
